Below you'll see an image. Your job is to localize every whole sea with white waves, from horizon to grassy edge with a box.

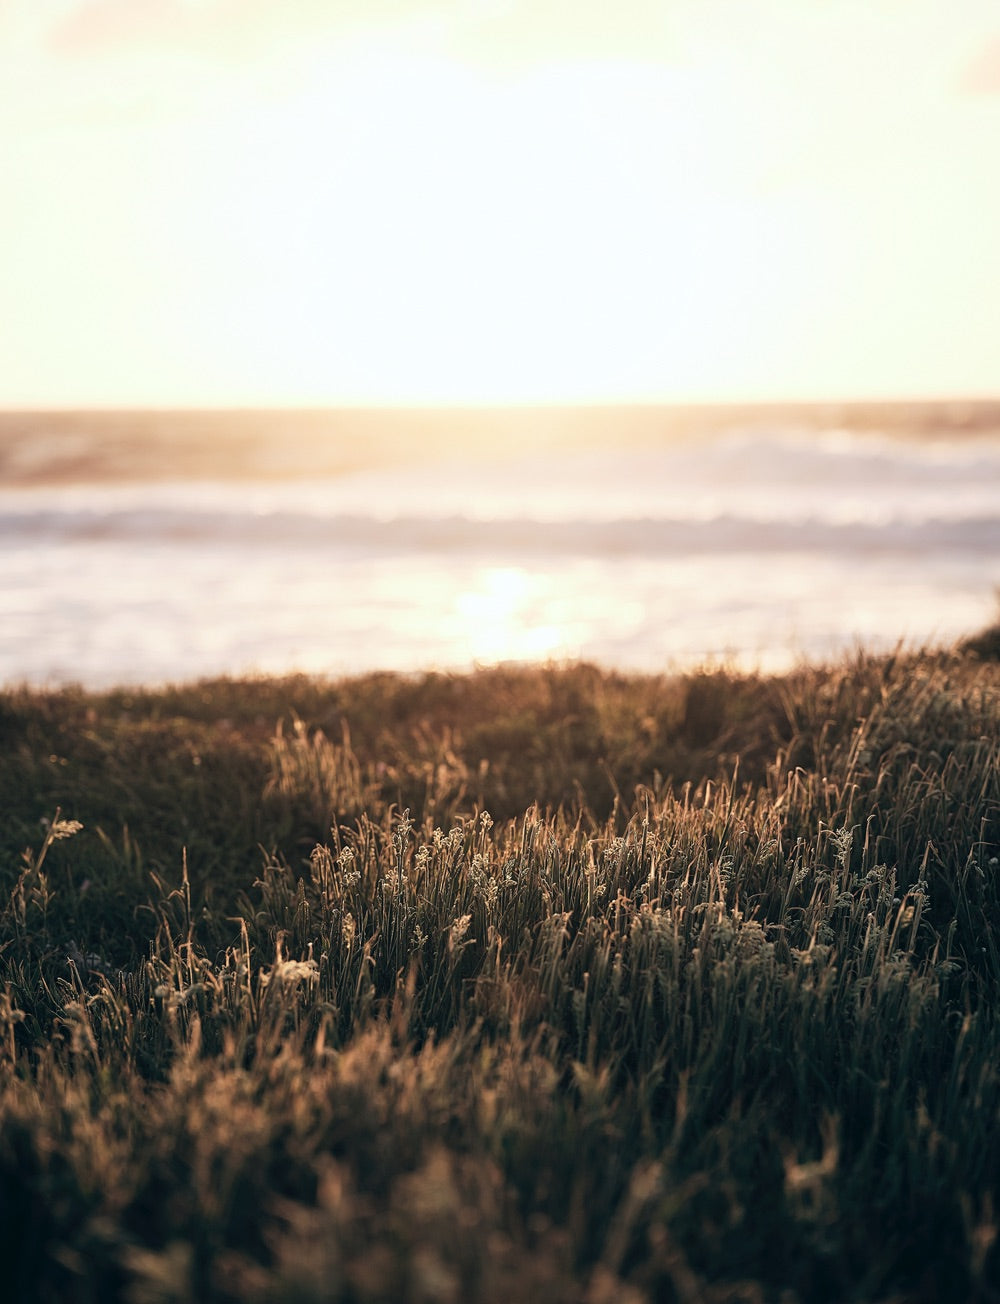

[0,404,1000,687]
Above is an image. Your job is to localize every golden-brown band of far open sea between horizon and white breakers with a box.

[0,399,1000,488]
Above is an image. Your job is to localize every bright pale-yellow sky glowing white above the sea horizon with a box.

[0,0,1000,407]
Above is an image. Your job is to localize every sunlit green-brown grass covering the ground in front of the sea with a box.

[0,638,1000,1304]
